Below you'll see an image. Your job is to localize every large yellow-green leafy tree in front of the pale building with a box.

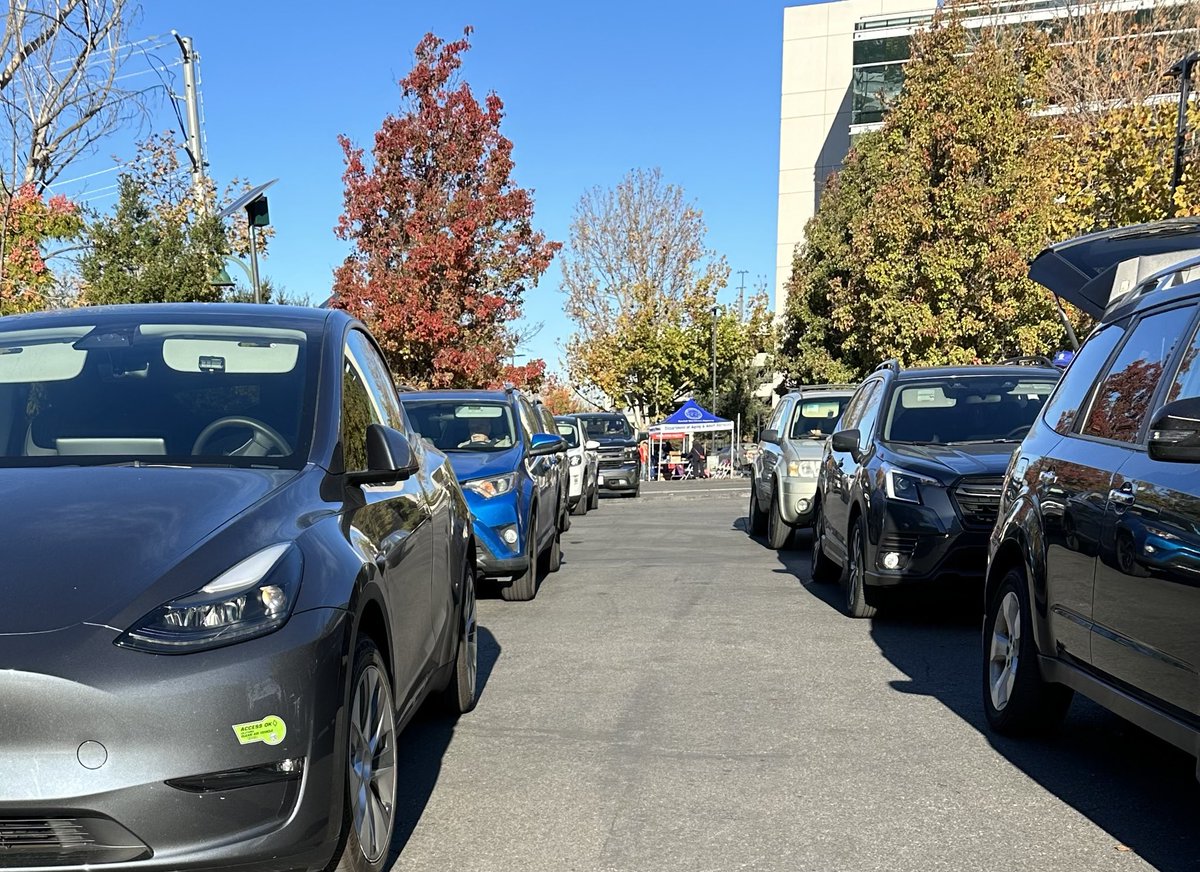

[782,11,1063,380]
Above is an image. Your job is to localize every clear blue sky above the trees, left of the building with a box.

[59,0,790,369]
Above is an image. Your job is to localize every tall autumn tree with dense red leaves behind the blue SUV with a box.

[334,28,559,387]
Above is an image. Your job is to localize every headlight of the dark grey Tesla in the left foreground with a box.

[116,542,302,654]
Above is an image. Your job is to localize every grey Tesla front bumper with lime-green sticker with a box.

[0,609,347,872]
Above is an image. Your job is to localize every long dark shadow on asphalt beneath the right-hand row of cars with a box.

[734,510,1200,872]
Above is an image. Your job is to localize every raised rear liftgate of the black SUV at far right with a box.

[1030,218,1200,318]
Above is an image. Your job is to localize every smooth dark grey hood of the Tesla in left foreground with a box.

[0,467,295,636]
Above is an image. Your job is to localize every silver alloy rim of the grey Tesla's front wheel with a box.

[349,663,396,866]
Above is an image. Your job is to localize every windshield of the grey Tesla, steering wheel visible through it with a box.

[0,319,314,467]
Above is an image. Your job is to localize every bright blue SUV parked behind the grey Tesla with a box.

[401,387,566,600]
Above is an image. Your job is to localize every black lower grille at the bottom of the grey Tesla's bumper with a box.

[0,818,151,868]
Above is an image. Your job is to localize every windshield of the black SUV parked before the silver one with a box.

[883,375,1056,445]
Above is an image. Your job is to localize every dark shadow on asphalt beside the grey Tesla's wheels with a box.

[385,626,503,868]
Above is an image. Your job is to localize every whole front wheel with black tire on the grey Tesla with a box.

[326,637,400,872]
